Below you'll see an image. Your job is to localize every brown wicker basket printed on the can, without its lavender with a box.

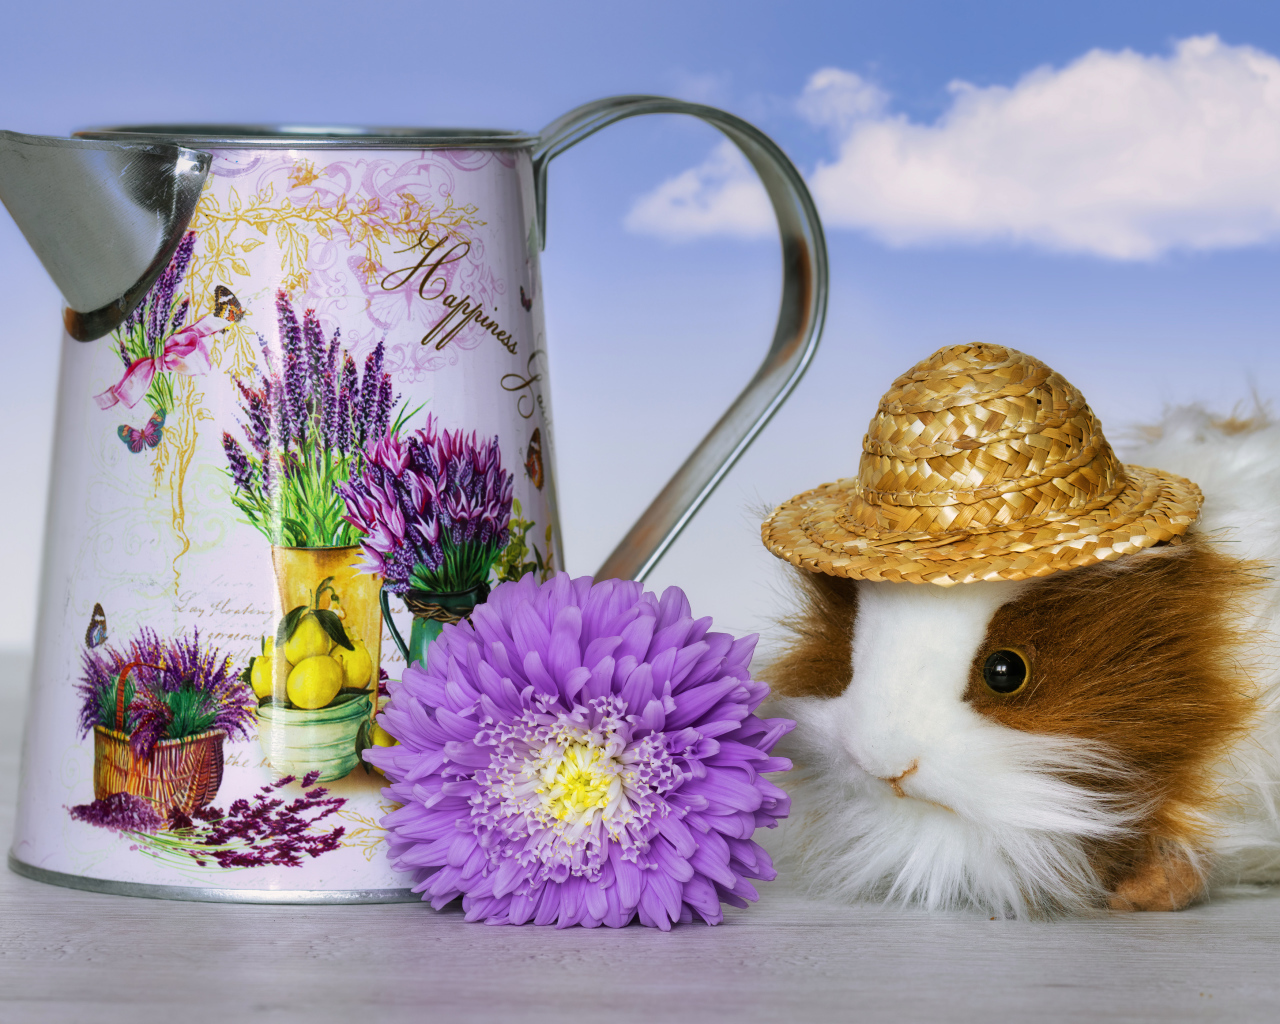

[93,726,227,817]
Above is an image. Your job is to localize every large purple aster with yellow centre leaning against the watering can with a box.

[365,573,795,929]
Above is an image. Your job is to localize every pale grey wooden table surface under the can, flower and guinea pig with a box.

[0,655,1280,1024]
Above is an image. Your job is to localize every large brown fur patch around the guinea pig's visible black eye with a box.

[965,540,1263,909]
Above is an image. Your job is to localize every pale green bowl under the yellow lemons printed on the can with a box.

[257,695,372,782]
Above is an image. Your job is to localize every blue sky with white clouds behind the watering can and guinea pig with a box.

[0,0,1280,646]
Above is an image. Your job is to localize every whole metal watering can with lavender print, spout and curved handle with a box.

[0,96,827,902]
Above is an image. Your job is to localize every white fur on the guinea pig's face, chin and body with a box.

[781,410,1280,916]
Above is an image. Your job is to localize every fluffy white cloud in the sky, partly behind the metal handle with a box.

[627,36,1280,260]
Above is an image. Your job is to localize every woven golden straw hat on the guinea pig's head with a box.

[762,344,1203,586]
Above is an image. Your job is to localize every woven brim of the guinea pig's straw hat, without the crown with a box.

[760,466,1204,586]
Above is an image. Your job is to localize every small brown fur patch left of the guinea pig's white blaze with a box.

[762,568,858,698]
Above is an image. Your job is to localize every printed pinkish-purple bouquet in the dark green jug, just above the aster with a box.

[338,413,515,598]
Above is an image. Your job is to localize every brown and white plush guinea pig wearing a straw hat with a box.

[763,344,1280,915]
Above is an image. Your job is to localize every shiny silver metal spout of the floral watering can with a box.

[0,131,210,342]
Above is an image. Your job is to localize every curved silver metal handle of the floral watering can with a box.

[534,96,827,580]
